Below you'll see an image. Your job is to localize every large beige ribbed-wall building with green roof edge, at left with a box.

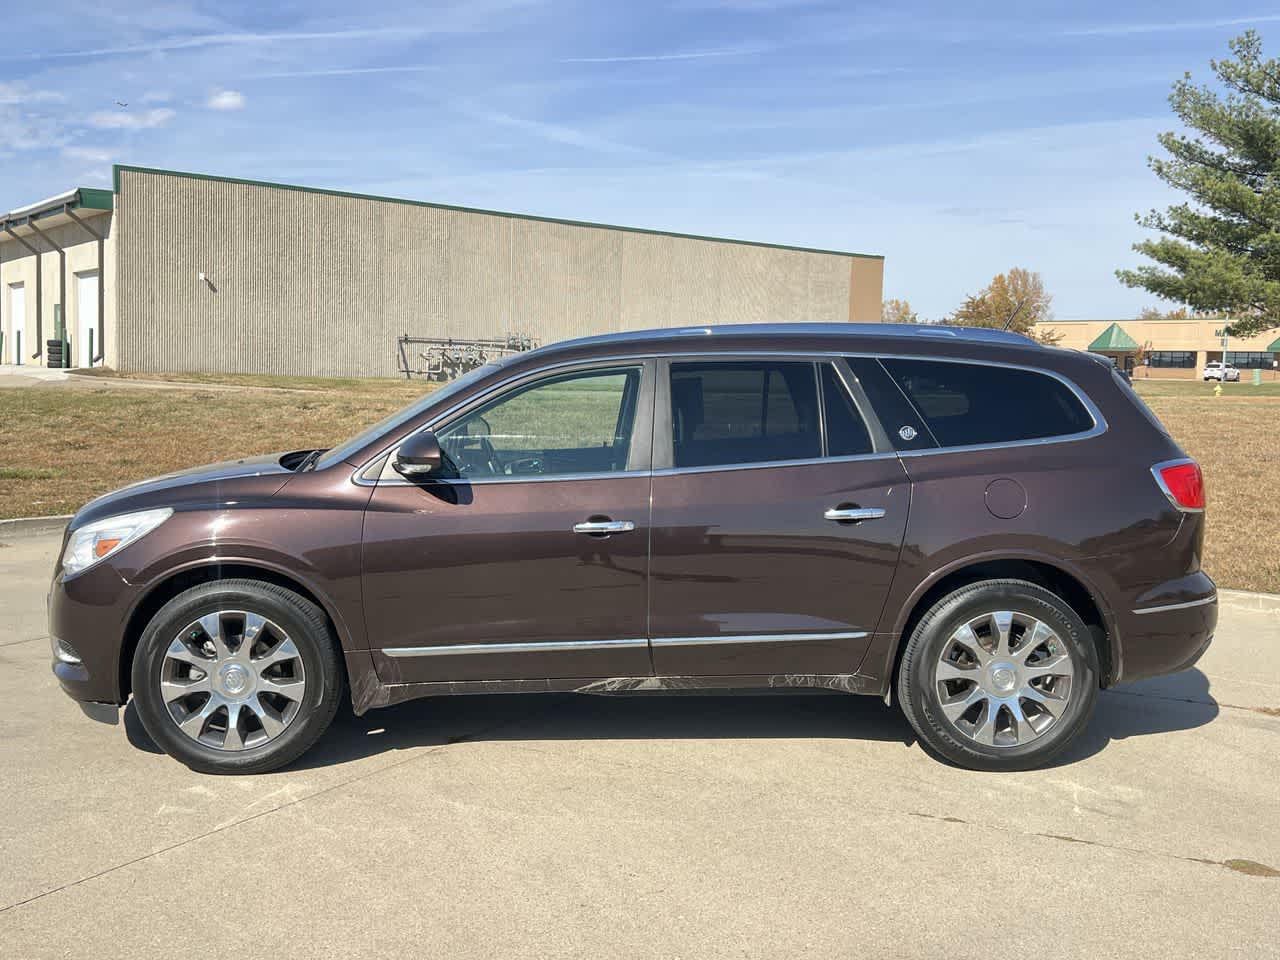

[0,166,883,376]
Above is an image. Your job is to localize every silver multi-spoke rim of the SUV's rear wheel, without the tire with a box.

[934,611,1075,748]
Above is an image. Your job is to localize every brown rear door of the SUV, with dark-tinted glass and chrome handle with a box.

[650,356,910,676]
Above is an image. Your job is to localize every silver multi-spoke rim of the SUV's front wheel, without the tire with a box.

[160,611,306,750]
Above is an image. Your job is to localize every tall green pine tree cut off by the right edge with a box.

[1116,31,1280,337]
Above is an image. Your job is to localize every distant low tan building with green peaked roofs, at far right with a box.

[1036,317,1280,380]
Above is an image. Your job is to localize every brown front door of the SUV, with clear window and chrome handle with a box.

[364,360,655,682]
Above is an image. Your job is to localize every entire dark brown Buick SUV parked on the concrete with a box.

[49,324,1217,772]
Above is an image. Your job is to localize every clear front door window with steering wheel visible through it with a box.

[438,366,643,479]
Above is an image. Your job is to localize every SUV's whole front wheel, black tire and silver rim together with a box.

[133,580,344,773]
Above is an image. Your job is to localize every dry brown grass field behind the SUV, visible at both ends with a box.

[0,375,1280,593]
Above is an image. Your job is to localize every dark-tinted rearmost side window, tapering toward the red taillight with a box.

[881,358,1093,447]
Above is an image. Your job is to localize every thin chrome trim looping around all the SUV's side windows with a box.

[351,349,1111,486]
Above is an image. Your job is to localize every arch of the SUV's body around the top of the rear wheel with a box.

[884,556,1120,690]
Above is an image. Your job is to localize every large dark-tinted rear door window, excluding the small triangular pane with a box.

[671,360,822,468]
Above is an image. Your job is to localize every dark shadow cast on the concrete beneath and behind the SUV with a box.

[124,669,1219,772]
